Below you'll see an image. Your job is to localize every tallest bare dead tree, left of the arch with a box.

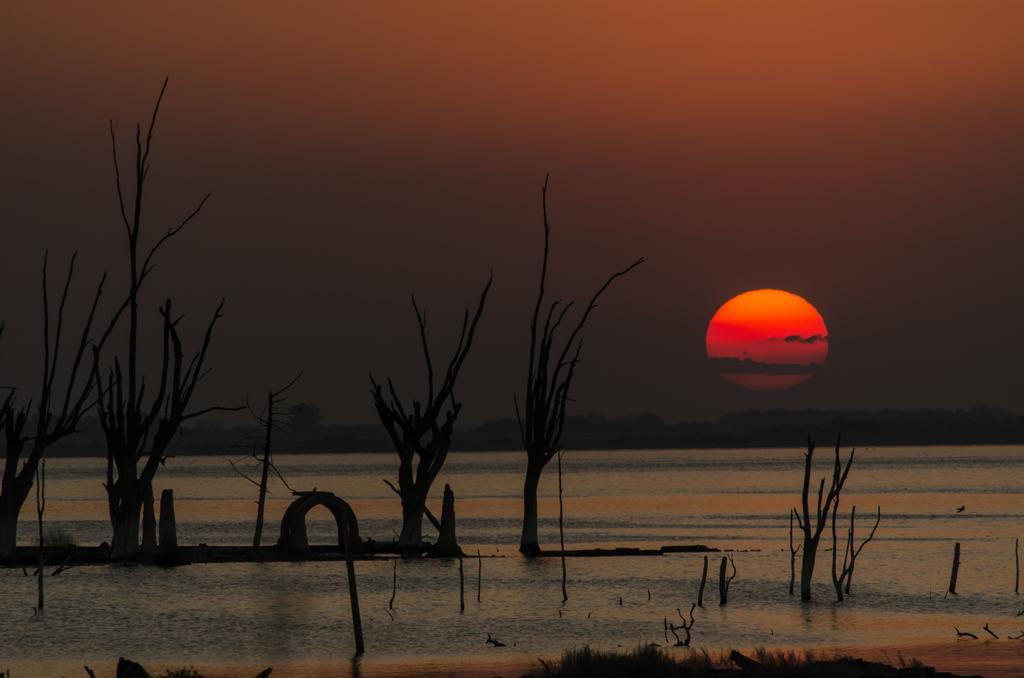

[94,79,241,558]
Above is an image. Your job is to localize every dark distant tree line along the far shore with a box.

[39,402,1024,456]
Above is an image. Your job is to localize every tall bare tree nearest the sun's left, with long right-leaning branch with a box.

[514,176,643,555]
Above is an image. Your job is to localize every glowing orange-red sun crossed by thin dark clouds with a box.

[706,290,828,390]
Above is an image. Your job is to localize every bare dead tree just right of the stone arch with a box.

[370,276,494,555]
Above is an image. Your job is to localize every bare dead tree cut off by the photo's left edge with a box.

[0,255,109,558]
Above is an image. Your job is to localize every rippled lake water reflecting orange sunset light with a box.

[0,447,1024,678]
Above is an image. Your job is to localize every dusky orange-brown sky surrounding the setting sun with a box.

[0,0,1024,422]
